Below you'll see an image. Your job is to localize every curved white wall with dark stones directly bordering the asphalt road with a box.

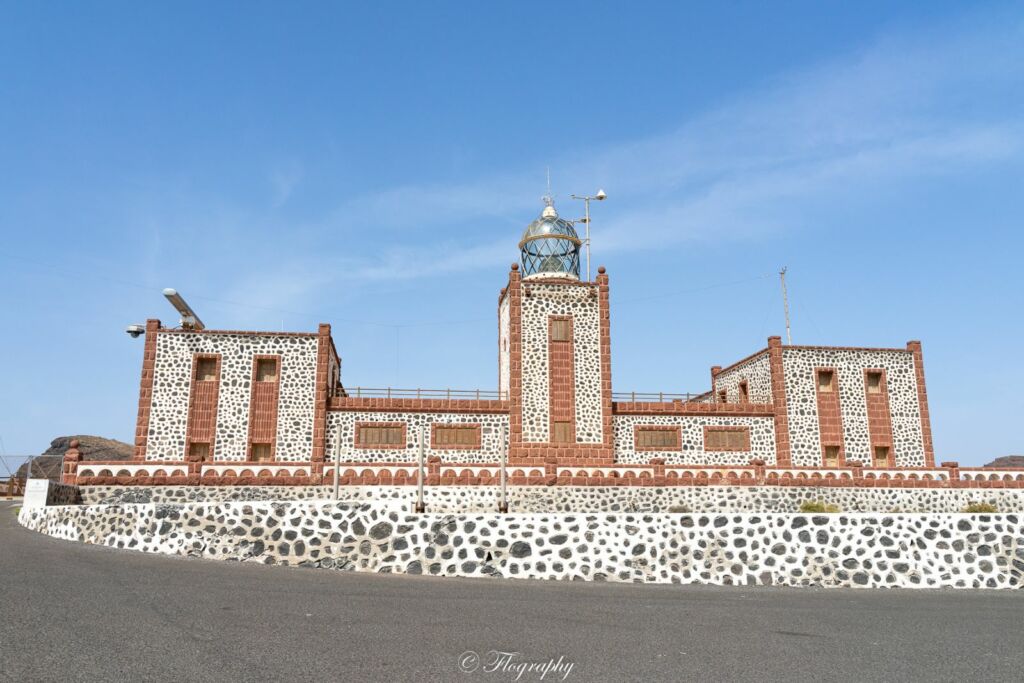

[19,502,1024,588]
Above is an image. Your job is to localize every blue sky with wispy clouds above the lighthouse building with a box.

[0,2,1024,464]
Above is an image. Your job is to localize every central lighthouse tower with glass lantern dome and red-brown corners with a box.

[498,198,613,465]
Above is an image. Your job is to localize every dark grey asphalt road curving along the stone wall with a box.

[0,503,1024,683]
